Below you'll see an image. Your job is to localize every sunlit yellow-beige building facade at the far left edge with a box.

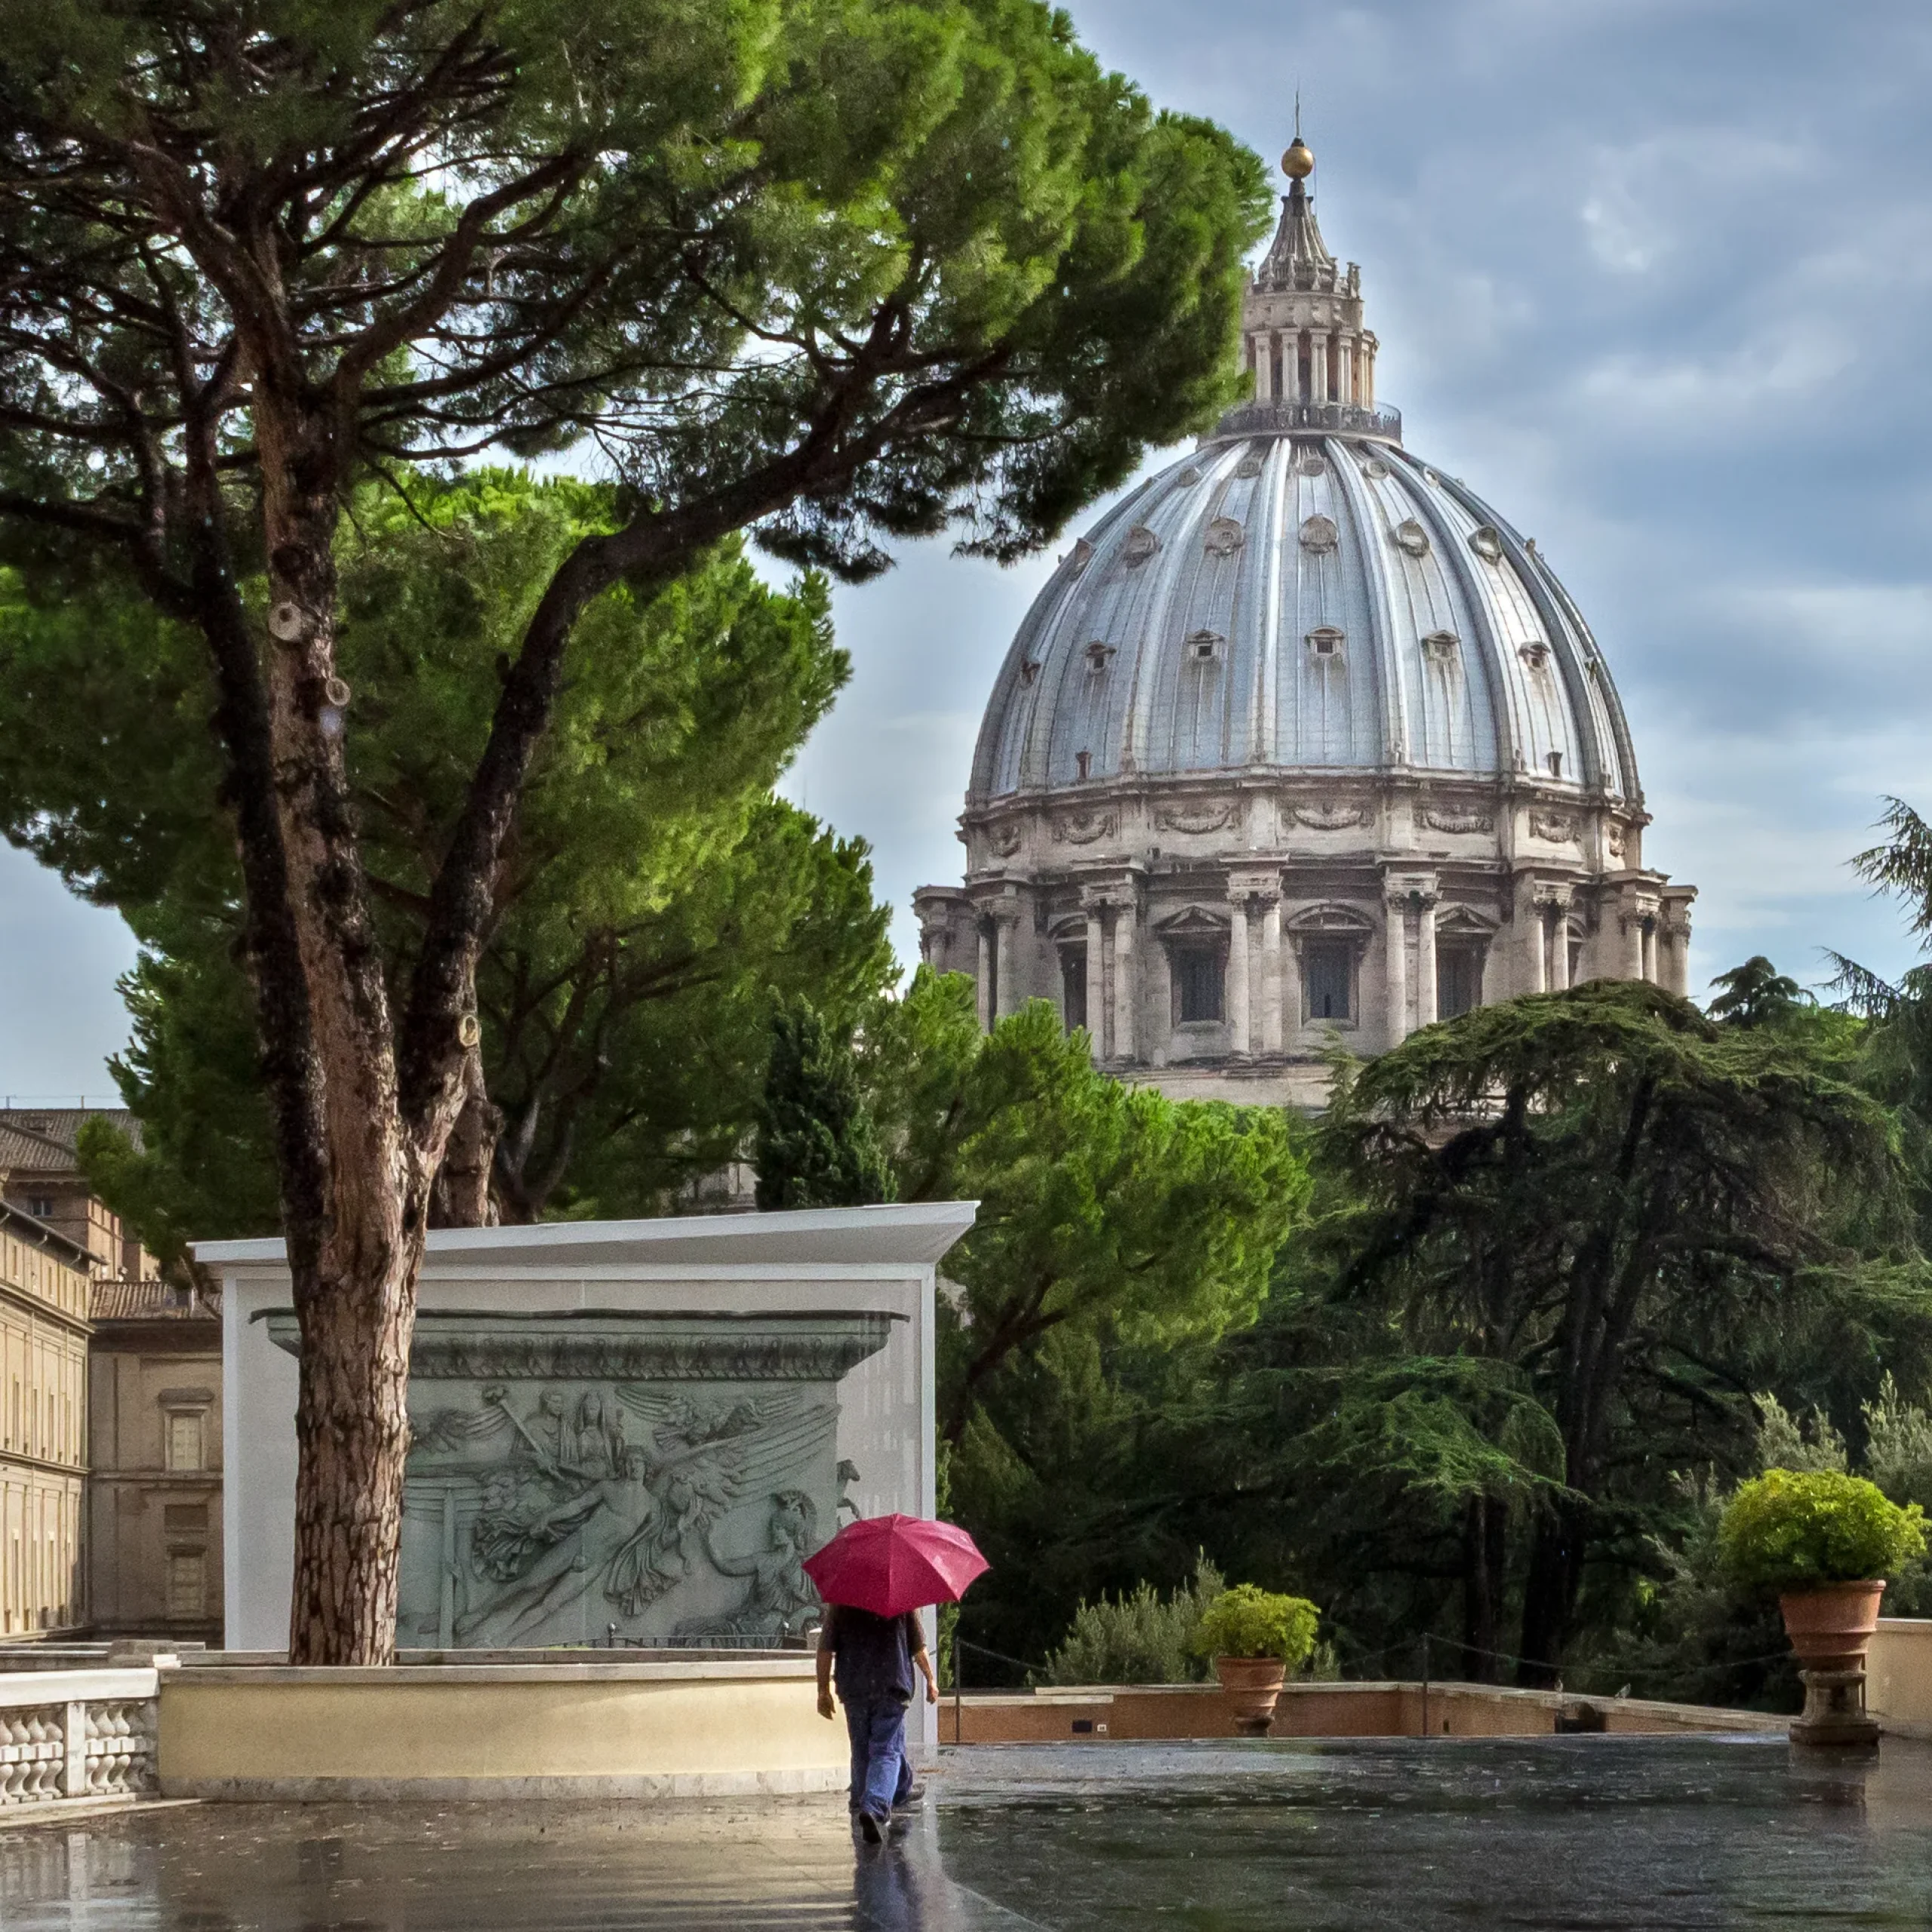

[0,1204,89,1636]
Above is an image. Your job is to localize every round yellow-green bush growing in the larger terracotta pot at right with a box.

[1718,1469,1926,1592]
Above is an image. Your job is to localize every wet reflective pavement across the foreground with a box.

[11,1737,1932,1932]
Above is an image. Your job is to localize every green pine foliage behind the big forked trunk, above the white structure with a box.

[0,472,893,1260]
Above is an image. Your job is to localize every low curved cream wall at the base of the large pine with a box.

[160,1652,848,1798]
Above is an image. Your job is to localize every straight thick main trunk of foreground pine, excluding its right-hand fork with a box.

[255,388,441,1663]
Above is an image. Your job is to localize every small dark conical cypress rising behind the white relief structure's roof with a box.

[758,999,893,1208]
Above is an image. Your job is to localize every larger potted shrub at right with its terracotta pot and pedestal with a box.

[1718,1469,1926,1745]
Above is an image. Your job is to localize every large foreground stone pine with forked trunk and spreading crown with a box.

[0,0,1267,1663]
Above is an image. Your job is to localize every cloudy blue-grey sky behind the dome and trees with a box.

[0,0,1932,1096]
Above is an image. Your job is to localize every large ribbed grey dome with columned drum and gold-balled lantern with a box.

[914,141,1694,1105]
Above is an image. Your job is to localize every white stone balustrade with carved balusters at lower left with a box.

[0,1667,156,1816]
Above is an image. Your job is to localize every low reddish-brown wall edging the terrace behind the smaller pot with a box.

[939,1677,1769,1745]
